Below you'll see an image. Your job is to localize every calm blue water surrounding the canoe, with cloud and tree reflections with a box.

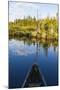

[9,39,58,88]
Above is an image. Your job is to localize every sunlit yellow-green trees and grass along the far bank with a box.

[8,16,58,40]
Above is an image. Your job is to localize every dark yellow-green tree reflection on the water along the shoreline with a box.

[9,36,58,48]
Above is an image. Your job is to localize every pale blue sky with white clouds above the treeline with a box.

[9,2,58,21]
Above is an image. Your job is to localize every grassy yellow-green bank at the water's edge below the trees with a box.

[9,28,58,40]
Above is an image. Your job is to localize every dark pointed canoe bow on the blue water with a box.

[22,64,46,87]
